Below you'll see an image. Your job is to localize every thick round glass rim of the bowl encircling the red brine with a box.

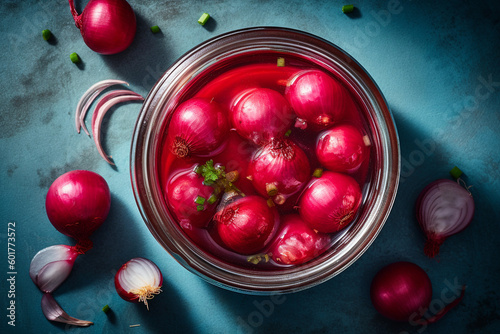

[130,27,400,294]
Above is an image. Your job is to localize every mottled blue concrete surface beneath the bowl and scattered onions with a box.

[0,0,500,333]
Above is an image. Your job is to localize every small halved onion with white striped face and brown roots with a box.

[115,257,163,309]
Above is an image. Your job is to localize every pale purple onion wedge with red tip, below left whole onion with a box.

[30,245,81,293]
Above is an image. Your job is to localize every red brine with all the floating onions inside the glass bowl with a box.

[157,51,373,270]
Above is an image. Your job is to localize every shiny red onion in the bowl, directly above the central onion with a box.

[231,88,295,145]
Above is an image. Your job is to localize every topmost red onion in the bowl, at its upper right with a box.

[285,70,350,130]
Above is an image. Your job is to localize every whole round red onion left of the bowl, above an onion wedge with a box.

[45,170,111,240]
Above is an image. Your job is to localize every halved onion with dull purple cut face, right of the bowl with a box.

[415,179,474,257]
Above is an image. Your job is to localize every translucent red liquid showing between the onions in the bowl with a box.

[157,52,373,270]
